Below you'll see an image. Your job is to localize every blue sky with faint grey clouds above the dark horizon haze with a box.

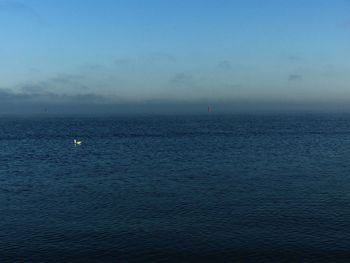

[0,0,350,114]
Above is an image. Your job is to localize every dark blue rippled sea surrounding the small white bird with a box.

[0,115,350,263]
